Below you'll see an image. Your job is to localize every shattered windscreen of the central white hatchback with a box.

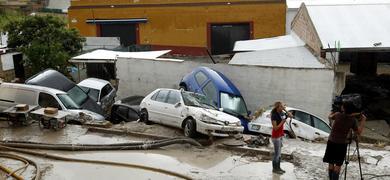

[181,91,217,109]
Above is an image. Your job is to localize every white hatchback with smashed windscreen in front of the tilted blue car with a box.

[140,89,244,137]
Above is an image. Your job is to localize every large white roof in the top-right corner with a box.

[306,4,390,49]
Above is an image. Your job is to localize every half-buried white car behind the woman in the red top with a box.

[248,107,331,140]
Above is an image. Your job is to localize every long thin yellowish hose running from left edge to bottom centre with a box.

[0,145,192,179]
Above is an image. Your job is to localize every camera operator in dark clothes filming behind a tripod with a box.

[323,101,366,180]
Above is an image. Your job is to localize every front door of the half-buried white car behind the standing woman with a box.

[287,110,315,140]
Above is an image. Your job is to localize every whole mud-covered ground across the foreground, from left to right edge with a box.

[0,122,390,180]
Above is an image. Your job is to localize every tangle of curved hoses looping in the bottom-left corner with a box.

[0,152,41,180]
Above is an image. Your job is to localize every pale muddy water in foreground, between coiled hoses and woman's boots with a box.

[34,148,295,180]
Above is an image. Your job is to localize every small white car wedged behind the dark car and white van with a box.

[77,78,116,112]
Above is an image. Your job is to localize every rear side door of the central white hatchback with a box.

[146,90,169,123]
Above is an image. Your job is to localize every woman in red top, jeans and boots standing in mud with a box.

[271,102,292,174]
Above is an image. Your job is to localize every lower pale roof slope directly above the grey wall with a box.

[229,46,325,68]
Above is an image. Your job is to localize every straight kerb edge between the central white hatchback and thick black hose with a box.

[88,127,174,140]
